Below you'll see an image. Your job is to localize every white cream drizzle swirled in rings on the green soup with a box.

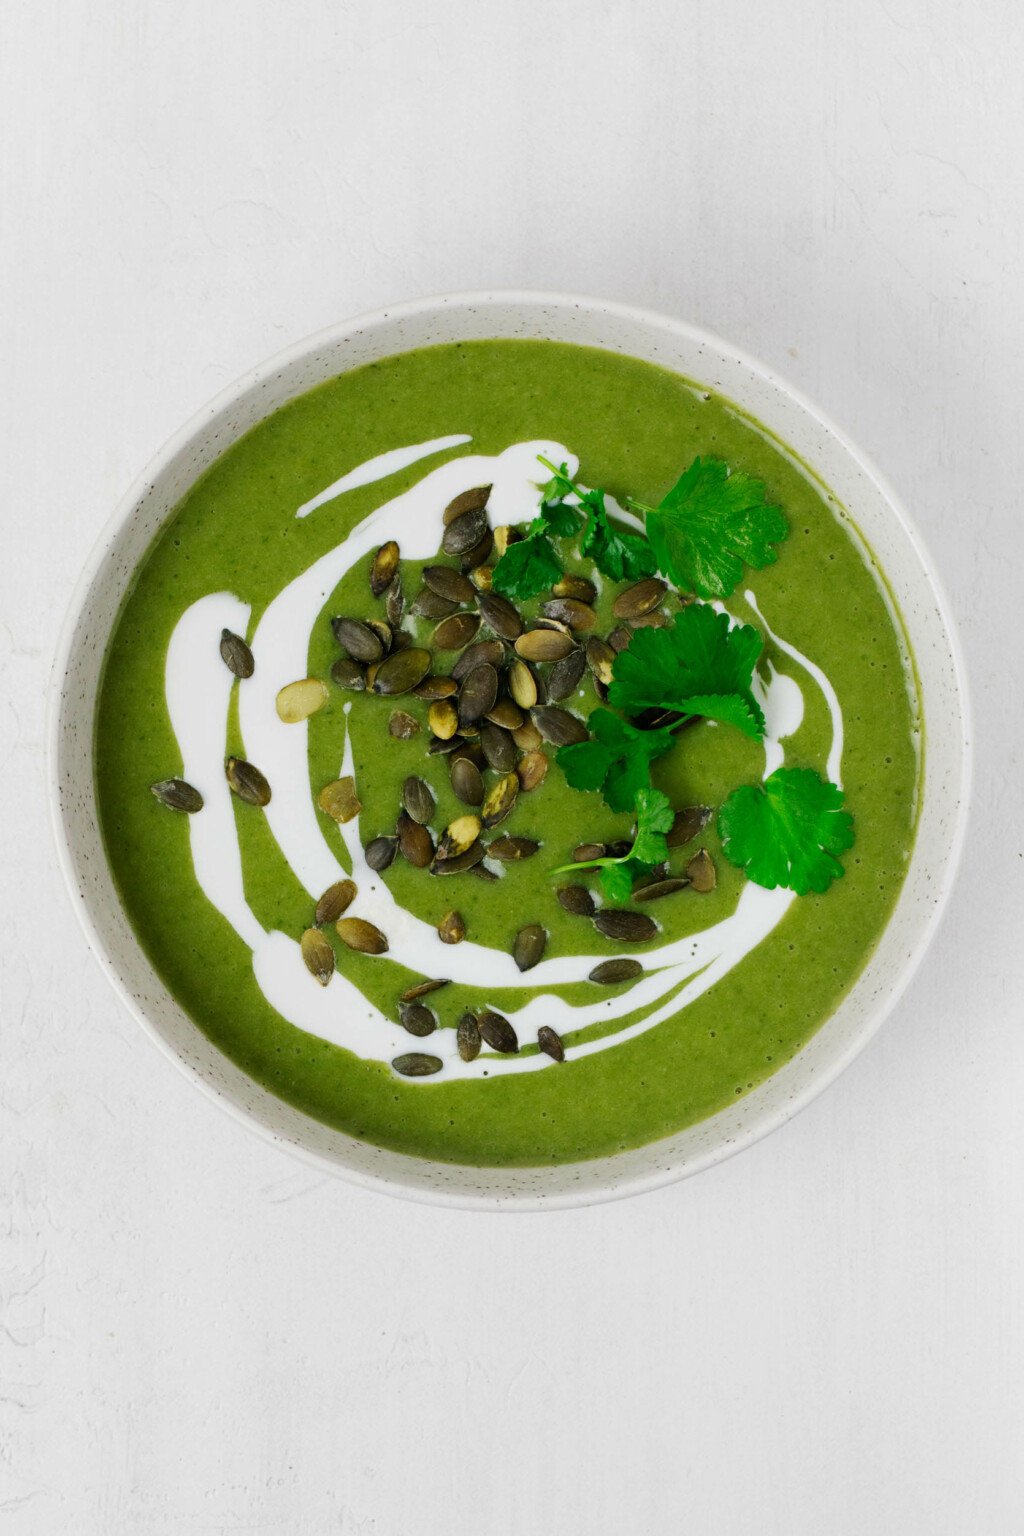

[166,438,843,1077]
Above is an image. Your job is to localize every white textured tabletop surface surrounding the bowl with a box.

[0,0,1024,1536]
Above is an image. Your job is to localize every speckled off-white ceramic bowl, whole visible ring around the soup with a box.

[49,292,970,1210]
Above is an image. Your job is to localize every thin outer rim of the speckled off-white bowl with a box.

[45,289,973,1212]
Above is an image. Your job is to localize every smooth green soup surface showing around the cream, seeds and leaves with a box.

[95,341,921,1164]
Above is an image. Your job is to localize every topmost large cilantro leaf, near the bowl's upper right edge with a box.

[629,458,789,598]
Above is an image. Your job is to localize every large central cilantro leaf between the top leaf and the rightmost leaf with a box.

[608,602,765,739]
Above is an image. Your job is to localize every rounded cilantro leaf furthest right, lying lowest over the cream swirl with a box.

[718,768,854,895]
